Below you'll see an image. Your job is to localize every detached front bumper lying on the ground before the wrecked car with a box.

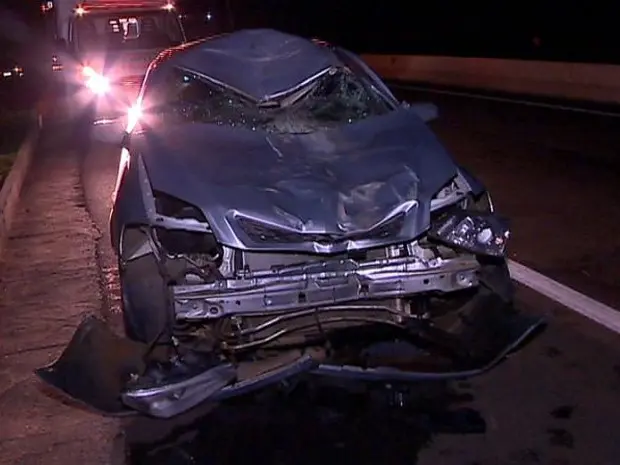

[36,293,544,418]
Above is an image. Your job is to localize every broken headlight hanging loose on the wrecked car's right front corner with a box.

[428,210,510,257]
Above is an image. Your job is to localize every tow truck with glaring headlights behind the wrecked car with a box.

[42,0,187,123]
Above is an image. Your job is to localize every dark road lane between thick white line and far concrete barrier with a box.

[396,84,620,309]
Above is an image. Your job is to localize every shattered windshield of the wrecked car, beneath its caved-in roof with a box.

[145,69,391,134]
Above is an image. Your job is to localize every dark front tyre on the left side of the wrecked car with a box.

[119,254,173,343]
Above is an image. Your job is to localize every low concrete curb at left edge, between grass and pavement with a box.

[0,115,43,256]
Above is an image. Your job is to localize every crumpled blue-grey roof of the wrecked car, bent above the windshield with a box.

[162,29,342,101]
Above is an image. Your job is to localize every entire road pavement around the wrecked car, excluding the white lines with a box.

[0,93,620,465]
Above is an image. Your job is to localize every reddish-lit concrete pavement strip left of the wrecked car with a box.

[0,127,117,465]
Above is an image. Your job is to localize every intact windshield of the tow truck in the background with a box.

[74,11,183,51]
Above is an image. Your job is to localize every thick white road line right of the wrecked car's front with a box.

[508,260,620,334]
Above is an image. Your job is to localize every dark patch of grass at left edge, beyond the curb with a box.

[0,110,34,188]
